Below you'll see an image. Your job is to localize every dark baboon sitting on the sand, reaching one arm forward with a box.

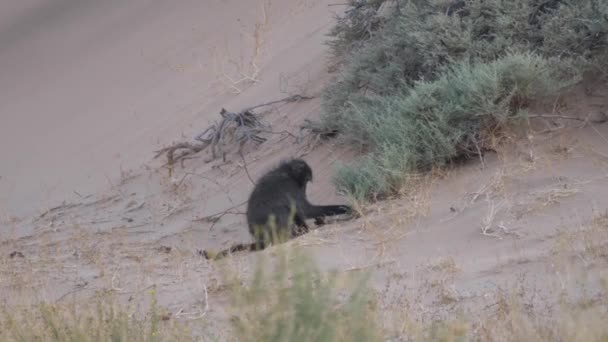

[203,159,352,259]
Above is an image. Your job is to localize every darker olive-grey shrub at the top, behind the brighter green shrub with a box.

[324,0,608,128]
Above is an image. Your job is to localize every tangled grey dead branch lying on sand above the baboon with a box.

[154,95,313,165]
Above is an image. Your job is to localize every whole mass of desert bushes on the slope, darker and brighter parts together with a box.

[321,0,608,198]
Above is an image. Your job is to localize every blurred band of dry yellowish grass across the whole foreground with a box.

[0,226,608,341]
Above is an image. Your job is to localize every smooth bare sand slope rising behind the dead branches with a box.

[0,0,331,216]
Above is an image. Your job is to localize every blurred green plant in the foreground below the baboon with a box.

[227,246,380,342]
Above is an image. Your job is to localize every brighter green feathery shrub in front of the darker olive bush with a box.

[335,53,569,200]
